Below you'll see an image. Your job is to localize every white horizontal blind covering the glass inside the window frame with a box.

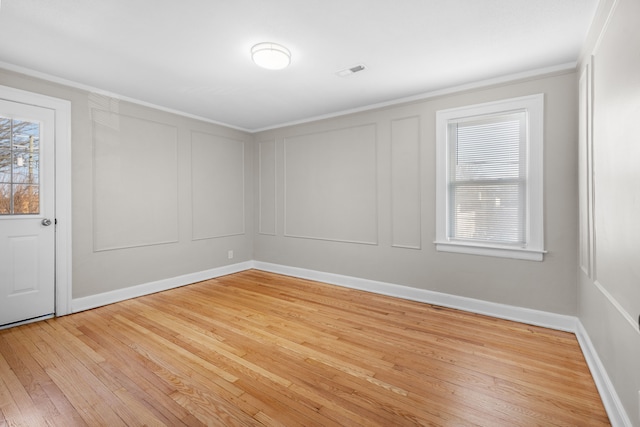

[448,111,527,246]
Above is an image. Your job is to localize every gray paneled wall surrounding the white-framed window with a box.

[254,72,578,315]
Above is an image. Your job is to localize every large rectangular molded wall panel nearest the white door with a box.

[91,108,179,252]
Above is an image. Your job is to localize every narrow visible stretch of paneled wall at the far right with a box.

[578,0,640,425]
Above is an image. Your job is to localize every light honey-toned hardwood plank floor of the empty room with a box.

[0,270,609,427]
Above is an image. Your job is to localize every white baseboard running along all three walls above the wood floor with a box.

[72,261,632,427]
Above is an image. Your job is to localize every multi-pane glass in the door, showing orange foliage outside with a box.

[0,116,40,215]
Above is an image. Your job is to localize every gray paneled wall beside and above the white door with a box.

[0,69,253,298]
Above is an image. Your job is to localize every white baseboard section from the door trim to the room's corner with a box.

[72,261,252,313]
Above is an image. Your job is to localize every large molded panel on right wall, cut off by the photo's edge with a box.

[592,1,640,327]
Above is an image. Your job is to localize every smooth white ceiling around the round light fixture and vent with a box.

[0,0,598,131]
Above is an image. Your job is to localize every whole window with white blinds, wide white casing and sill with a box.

[435,94,544,261]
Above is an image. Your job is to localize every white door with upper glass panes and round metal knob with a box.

[0,99,55,327]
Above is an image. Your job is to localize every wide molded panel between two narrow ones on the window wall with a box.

[284,124,378,245]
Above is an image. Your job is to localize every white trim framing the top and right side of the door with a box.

[0,85,72,316]
